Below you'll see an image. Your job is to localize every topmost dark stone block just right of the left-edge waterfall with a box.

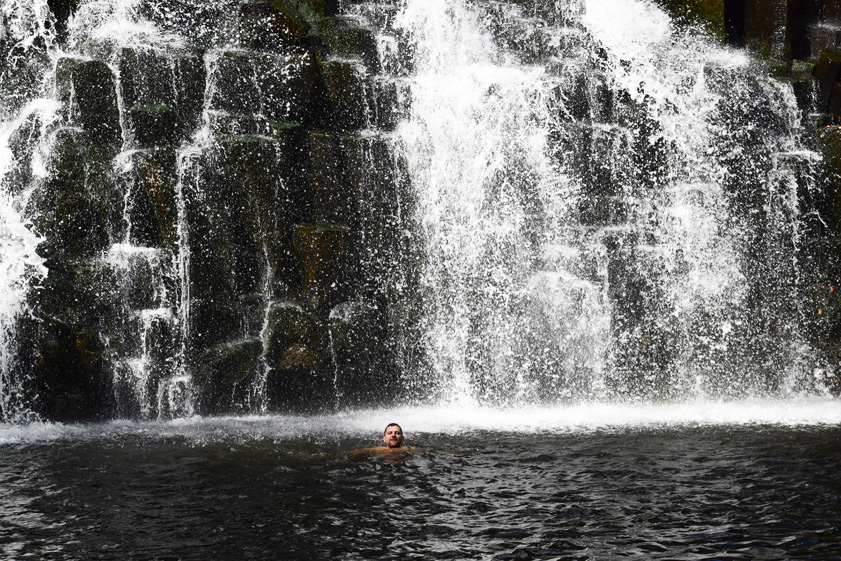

[56,57,122,148]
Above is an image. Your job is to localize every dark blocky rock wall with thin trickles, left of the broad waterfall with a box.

[8,0,410,421]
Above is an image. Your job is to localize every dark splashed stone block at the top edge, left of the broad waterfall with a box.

[238,1,310,50]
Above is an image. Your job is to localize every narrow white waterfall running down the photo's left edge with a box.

[0,2,55,422]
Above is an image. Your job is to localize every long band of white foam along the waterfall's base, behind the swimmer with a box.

[0,398,841,445]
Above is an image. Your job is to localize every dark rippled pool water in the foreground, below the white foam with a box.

[0,414,841,560]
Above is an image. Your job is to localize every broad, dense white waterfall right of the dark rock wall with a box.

[396,0,817,404]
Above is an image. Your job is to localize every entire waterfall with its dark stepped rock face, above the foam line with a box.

[0,0,826,419]
